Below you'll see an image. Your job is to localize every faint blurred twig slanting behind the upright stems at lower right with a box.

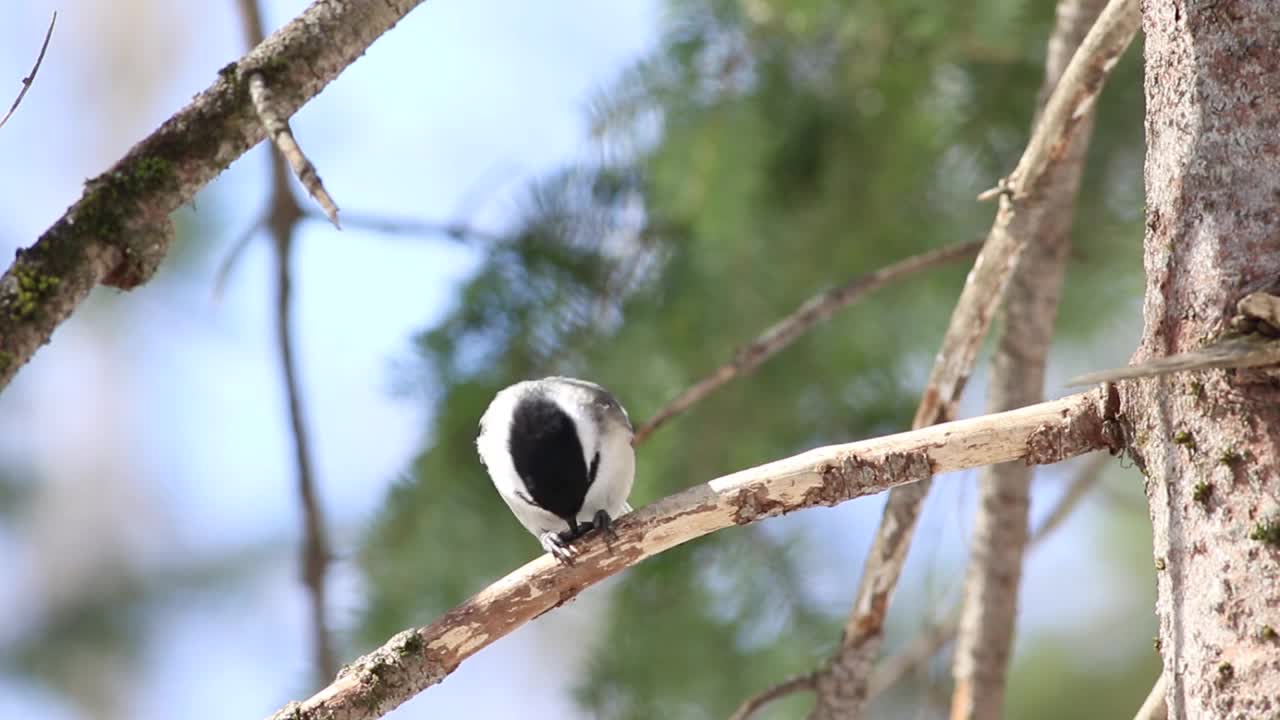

[867,452,1111,701]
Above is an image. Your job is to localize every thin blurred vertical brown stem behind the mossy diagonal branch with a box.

[235,0,338,682]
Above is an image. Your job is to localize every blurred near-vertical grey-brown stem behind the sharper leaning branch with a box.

[951,0,1106,720]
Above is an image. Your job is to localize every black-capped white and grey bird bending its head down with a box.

[476,377,635,565]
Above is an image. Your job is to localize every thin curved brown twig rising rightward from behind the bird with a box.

[636,241,982,445]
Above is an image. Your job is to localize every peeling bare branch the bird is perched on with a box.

[264,391,1114,720]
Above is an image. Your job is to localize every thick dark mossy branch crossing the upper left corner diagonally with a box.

[0,0,432,389]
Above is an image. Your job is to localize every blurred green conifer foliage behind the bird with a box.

[360,0,1143,719]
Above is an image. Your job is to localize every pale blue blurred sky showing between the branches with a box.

[0,0,1152,720]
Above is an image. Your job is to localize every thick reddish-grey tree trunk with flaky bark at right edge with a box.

[1123,0,1280,719]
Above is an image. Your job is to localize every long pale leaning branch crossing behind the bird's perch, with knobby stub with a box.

[812,0,1138,720]
